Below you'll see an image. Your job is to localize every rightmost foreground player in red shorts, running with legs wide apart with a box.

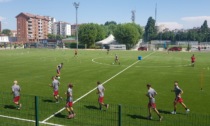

[171,81,190,114]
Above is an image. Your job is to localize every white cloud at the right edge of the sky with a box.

[181,16,210,28]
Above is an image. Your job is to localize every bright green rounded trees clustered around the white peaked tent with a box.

[78,21,143,49]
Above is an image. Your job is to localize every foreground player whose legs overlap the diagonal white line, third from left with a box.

[66,83,76,119]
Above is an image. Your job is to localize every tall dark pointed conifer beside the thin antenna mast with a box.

[144,17,157,42]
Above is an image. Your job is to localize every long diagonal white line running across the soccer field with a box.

[42,52,155,123]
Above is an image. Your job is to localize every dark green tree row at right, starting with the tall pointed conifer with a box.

[143,17,210,42]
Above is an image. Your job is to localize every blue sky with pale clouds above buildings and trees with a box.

[0,0,210,30]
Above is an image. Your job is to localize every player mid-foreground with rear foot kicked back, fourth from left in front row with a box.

[97,81,109,110]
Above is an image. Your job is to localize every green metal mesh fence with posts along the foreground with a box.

[0,93,210,126]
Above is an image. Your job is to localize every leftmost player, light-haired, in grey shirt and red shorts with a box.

[12,80,22,109]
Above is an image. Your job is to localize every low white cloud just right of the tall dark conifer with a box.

[157,22,183,30]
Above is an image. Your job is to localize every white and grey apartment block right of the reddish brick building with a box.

[52,21,71,37]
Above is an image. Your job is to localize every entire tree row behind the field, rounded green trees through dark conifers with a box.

[79,17,210,49]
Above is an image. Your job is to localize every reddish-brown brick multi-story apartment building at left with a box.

[16,13,49,42]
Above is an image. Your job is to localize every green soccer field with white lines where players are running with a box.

[0,49,210,126]
